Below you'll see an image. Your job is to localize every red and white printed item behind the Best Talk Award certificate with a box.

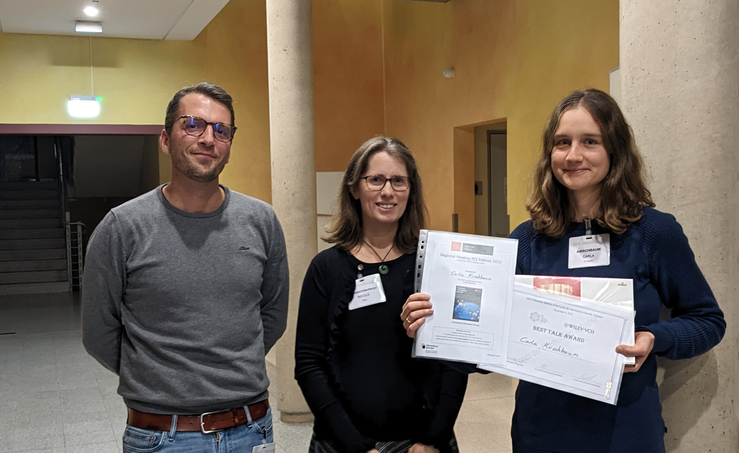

[516,275,636,365]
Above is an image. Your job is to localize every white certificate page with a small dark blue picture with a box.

[414,230,518,364]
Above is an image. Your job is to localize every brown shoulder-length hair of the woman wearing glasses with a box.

[324,136,426,253]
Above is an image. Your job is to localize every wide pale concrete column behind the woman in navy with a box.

[620,0,739,453]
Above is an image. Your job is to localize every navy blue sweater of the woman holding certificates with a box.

[455,208,726,453]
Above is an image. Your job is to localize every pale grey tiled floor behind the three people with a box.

[0,294,513,453]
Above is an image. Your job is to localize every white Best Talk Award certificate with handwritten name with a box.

[480,285,634,405]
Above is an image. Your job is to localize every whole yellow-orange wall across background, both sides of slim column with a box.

[0,0,618,219]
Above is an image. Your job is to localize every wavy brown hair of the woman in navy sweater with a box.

[526,89,654,237]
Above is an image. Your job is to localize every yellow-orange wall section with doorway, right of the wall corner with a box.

[384,0,619,232]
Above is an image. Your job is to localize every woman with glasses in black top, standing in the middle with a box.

[295,137,467,453]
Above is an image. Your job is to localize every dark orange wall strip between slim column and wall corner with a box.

[312,0,385,171]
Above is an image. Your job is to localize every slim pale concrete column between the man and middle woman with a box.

[267,0,317,422]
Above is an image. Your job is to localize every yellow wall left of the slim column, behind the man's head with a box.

[0,0,271,201]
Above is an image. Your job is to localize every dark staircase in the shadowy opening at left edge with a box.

[0,181,70,296]
